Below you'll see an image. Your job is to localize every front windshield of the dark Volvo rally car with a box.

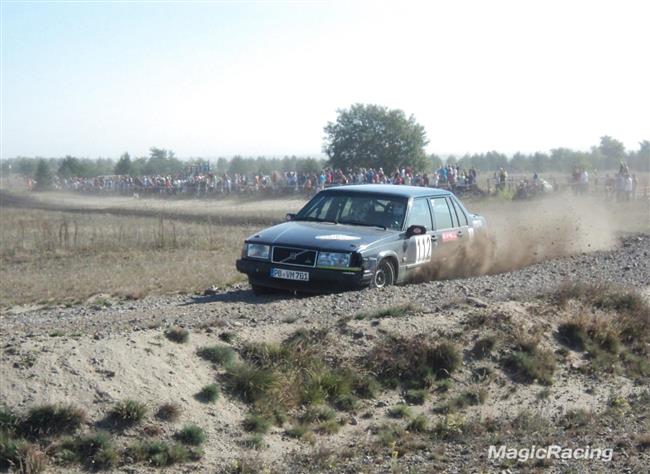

[296,193,407,230]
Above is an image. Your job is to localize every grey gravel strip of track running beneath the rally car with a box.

[0,234,650,337]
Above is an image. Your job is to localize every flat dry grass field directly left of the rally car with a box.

[0,209,254,306]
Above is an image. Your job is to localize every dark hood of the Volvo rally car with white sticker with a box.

[246,221,392,252]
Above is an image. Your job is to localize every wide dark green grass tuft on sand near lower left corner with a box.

[20,405,87,437]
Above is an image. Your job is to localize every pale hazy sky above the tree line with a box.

[1,0,650,157]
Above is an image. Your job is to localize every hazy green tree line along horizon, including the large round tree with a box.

[2,104,650,188]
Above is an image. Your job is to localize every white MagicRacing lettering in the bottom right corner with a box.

[488,444,614,462]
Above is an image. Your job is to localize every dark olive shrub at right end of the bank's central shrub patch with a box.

[368,337,461,388]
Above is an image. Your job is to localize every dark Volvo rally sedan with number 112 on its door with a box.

[237,184,487,293]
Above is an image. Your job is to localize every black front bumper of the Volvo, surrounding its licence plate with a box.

[236,258,372,293]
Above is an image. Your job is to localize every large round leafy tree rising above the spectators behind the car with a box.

[323,104,428,173]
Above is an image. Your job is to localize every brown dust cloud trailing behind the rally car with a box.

[418,195,650,280]
